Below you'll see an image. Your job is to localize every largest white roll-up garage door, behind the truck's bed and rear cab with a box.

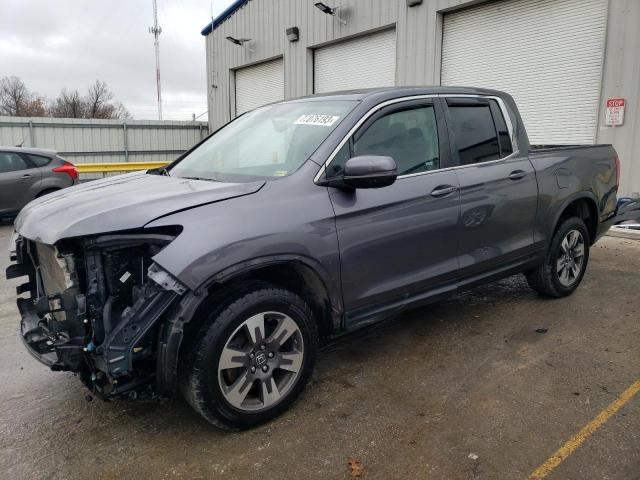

[441,0,607,143]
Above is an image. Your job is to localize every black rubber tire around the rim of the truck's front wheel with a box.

[180,282,318,430]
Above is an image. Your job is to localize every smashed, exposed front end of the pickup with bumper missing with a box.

[7,227,186,398]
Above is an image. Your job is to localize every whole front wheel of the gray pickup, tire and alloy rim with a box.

[181,284,318,430]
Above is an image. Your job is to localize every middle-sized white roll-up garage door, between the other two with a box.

[313,30,396,93]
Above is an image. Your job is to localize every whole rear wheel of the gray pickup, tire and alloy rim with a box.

[527,217,590,298]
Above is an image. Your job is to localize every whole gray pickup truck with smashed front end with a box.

[7,87,619,429]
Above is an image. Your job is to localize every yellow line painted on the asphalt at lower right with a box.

[529,380,640,480]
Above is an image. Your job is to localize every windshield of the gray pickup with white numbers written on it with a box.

[169,100,357,182]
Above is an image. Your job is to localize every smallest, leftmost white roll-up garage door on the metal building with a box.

[236,58,284,115]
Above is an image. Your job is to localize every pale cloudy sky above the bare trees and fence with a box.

[0,0,232,120]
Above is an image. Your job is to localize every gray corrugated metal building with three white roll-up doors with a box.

[202,0,640,195]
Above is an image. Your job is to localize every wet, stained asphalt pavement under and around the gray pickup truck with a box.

[0,225,640,480]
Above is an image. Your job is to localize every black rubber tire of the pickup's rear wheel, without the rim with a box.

[526,217,591,298]
